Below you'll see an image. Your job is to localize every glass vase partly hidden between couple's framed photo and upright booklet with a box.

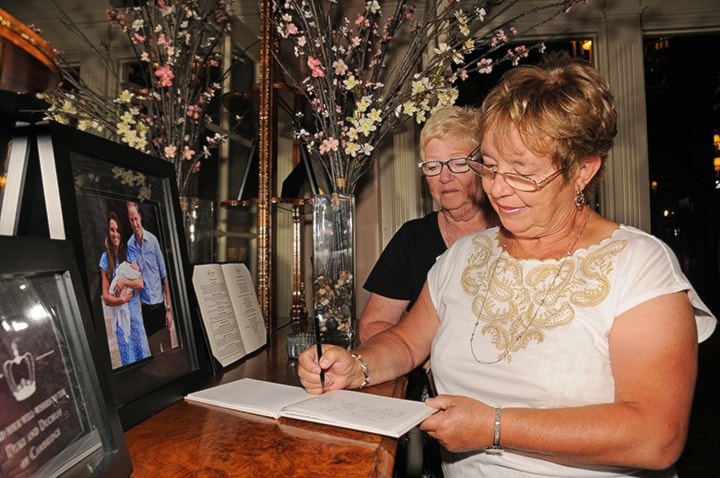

[180,196,215,264]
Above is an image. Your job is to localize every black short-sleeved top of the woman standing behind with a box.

[364,212,447,310]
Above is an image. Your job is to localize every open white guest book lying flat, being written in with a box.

[185,378,437,438]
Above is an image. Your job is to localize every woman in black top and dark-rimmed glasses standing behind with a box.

[359,106,497,342]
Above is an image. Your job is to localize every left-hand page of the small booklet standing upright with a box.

[192,264,247,367]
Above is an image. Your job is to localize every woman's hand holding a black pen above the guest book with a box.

[298,344,364,395]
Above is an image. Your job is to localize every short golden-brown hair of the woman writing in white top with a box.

[480,53,617,193]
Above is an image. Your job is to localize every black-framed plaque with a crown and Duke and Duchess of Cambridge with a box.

[0,237,132,477]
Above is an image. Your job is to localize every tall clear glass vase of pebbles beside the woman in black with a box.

[312,194,356,348]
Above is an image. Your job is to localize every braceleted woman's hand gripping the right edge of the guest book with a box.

[420,395,495,453]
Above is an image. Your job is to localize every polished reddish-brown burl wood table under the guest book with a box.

[125,327,407,478]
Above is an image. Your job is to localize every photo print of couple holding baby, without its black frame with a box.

[93,197,178,369]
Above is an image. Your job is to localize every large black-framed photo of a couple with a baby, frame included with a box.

[31,124,212,429]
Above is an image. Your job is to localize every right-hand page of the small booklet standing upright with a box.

[222,262,267,353]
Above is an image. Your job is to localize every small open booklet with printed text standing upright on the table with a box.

[192,263,267,367]
